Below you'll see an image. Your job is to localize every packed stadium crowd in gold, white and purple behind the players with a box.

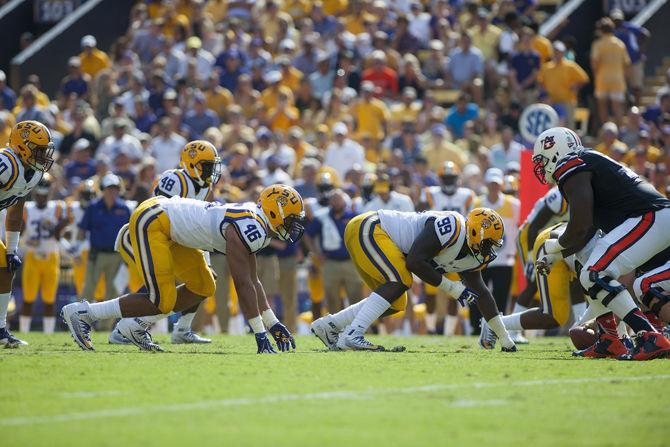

[0,0,670,333]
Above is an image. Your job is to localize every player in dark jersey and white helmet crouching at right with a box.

[533,127,670,360]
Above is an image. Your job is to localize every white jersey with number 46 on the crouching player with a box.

[158,197,270,254]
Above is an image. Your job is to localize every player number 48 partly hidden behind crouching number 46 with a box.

[109,140,222,344]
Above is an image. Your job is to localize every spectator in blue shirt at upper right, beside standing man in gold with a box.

[610,9,651,104]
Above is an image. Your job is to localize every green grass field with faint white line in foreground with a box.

[0,333,670,447]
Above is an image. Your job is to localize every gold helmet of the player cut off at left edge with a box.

[9,121,55,172]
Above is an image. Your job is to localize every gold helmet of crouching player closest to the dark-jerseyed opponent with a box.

[465,208,505,264]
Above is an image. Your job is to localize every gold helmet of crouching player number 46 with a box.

[258,184,305,242]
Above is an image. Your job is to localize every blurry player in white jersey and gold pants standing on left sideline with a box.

[19,173,69,334]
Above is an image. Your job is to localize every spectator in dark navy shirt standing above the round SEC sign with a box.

[509,27,541,105]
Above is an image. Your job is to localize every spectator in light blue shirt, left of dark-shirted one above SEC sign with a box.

[447,32,484,104]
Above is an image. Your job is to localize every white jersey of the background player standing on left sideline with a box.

[22,200,66,256]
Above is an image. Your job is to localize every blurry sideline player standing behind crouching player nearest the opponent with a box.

[419,161,475,335]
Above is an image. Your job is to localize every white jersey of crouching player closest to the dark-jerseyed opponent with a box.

[377,210,481,273]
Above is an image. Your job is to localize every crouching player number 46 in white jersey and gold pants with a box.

[61,184,305,354]
